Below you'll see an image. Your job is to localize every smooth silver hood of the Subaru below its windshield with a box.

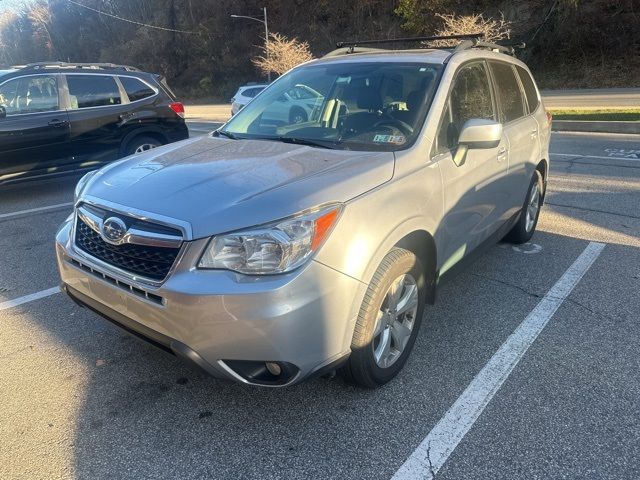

[83,136,394,238]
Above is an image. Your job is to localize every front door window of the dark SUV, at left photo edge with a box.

[0,75,59,115]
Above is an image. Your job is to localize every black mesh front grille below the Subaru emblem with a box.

[76,217,180,281]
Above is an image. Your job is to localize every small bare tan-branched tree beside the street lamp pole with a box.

[252,33,313,75]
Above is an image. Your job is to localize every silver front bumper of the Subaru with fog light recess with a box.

[56,219,366,386]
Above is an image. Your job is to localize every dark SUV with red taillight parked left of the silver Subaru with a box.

[0,63,189,184]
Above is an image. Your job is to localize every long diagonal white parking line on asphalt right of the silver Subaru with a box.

[392,242,605,480]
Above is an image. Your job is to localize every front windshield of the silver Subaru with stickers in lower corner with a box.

[220,62,442,151]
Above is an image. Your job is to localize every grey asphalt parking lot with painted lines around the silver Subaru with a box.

[0,128,640,479]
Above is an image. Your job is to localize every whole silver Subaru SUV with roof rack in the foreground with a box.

[56,41,551,388]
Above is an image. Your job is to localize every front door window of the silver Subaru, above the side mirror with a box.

[437,62,495,153]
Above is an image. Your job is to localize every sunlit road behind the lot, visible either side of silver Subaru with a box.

[186,88,640,122]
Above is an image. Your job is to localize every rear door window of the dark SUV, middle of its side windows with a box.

[67,75,122,110]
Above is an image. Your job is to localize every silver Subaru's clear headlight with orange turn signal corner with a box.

[198,205,342,275]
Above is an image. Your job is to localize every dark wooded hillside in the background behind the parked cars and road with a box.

[0,0,640,99]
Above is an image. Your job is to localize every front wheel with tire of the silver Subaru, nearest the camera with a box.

[341,248,425,388]
